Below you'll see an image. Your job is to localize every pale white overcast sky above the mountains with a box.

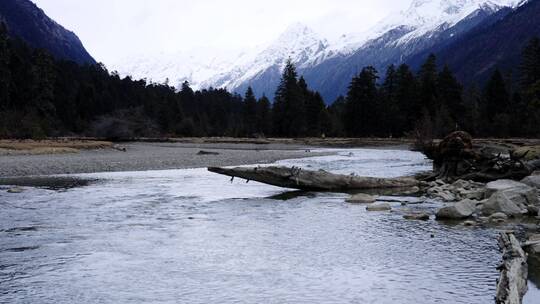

[33,0,411,63]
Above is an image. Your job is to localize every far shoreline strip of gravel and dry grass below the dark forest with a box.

[0,137,540,177]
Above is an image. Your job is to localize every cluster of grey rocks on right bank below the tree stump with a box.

[427,175,540,222]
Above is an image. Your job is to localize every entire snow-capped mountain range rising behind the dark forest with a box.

[112,0,519,98]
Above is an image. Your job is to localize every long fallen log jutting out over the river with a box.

[208,167,420,191]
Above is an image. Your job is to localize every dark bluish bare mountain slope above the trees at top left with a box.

[0,0,95,64]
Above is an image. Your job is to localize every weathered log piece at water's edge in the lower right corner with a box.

[495,232,528,304]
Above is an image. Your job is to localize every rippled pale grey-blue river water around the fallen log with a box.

[0,149,536,304]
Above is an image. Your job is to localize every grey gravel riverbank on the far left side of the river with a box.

[0,142,330,177]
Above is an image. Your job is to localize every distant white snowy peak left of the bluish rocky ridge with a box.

[110,23,328,89]
